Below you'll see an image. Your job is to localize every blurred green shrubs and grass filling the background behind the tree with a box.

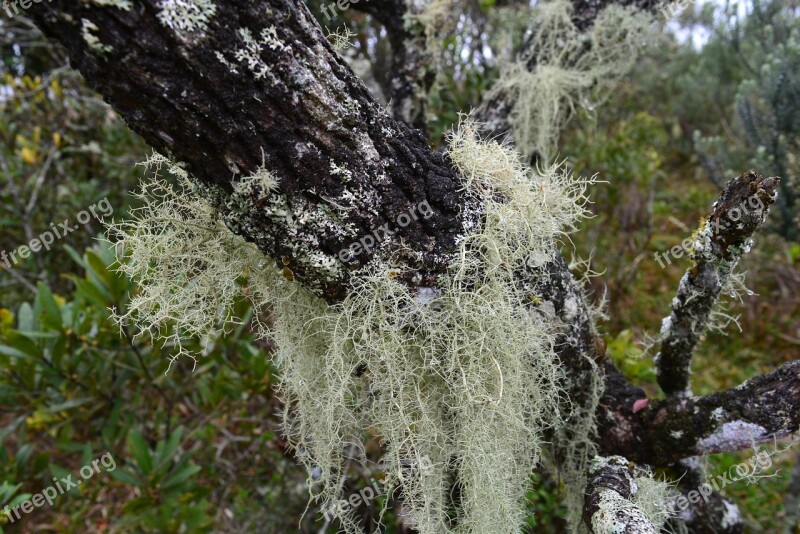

[0,0,800,533]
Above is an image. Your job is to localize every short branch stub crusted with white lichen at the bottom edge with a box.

[583,456,658,534]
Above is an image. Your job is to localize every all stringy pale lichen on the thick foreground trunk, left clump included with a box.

[112,122,593,533]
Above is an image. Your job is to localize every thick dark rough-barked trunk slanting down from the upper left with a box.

[30,0,476,301]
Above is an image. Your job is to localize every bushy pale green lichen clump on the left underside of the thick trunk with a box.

[104,155,263,370]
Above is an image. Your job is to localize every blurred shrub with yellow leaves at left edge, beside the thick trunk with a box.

[0,38,144,305]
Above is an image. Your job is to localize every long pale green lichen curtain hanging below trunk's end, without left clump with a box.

[278,123,583,533]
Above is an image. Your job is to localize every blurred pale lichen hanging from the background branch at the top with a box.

[490,0,651,164]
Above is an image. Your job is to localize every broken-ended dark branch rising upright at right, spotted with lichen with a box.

[655,171,778,396]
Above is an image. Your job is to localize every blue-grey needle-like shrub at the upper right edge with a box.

[687,0,800,241]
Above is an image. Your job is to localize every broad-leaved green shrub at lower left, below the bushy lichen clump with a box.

[0,241,311,532]
